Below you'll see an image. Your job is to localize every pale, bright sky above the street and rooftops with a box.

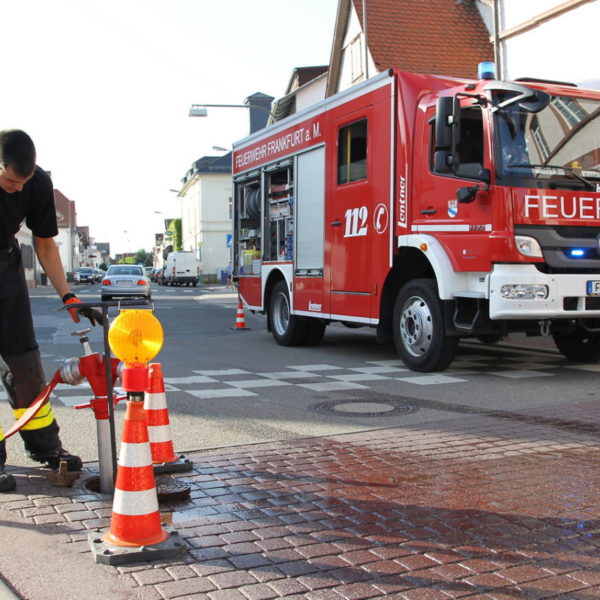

[0,0,338,256]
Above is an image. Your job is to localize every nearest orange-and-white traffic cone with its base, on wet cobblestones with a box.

[88,400,185,565]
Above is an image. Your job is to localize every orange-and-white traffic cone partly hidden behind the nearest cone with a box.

[144,363,193,473]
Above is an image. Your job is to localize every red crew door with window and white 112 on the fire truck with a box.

[326,112,373,319]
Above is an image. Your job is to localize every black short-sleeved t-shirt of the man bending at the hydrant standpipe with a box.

[0,167,58,249]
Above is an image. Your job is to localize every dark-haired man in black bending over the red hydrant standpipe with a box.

[0,129,102,491]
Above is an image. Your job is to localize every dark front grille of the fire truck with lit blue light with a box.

[515,225,600,274]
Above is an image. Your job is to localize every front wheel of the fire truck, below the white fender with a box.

[393,279,458,373]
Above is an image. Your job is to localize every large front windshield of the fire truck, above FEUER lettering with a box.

[494,96,600,192]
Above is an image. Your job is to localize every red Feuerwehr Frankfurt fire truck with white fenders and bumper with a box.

[233,62,600,372]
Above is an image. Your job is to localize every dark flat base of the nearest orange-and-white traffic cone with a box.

[88,528,186,565]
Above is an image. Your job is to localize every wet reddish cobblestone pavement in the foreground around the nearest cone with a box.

[0,399,600,600]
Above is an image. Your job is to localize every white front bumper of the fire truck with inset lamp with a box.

[489,264,600,320]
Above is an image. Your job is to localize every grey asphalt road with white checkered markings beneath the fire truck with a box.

[0,285,600,474]
